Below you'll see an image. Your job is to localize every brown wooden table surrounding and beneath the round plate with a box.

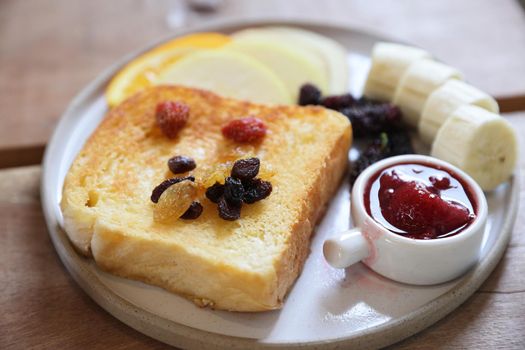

[0,0,525,349]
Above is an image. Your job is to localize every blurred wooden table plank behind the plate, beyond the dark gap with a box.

[0,0,525,153]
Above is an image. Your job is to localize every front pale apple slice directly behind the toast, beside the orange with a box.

[159,49,292,104]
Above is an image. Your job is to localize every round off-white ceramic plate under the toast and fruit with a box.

[41,21,519,348]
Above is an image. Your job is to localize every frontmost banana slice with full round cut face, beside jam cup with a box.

[431,105,518,191]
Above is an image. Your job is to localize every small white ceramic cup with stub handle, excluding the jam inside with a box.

[323,155,488,285]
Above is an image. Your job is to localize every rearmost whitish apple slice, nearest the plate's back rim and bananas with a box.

[232,27,348,94]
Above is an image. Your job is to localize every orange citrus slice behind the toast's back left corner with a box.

[106,33,231,107]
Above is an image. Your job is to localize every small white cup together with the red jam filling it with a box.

[323,155,488,285]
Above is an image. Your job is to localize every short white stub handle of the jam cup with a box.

[323,227,370,269]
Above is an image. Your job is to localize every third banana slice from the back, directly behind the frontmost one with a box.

[418,80,499,145]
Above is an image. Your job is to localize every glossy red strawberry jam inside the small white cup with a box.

[364,163,477,239]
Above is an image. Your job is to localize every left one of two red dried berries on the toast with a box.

[155,101,190,139]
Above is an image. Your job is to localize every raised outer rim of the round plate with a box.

[40,18,519,349]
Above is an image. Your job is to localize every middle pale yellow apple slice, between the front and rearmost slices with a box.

[224,37,328,102]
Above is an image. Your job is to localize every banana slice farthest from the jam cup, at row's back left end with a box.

[364,42,431,101]
